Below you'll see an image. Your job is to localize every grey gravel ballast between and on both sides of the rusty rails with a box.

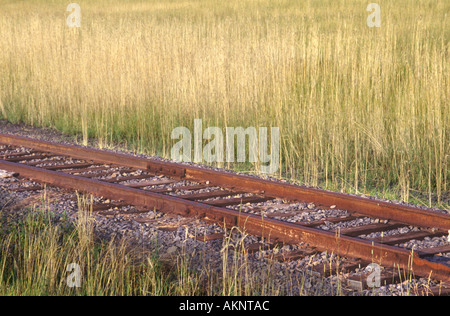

[0,121,450,295]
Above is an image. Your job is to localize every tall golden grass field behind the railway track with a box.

[0,0,450,205]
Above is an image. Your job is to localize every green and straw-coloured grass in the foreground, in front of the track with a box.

[0,195,298,296]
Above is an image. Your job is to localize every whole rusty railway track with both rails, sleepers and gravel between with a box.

[0,134,450,292]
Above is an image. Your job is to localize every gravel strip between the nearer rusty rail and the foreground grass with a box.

[0,175,448,295]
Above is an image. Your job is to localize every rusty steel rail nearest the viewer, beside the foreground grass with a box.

[0,160,450,281]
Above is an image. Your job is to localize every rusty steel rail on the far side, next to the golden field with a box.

[0,134,450,231]
